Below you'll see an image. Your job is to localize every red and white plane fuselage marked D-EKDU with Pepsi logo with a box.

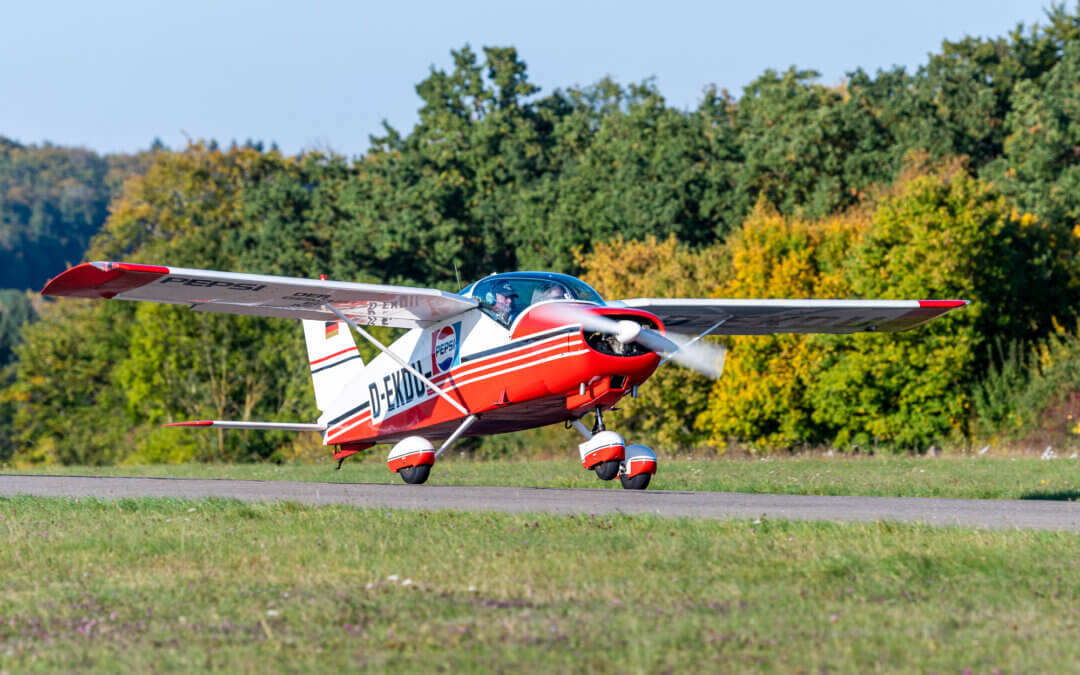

[319,305,663,446]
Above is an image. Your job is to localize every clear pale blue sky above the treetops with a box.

[0,0,1058,154]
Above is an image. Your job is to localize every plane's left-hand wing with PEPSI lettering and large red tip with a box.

[41,262,477,328]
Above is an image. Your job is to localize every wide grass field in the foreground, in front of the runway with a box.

[0,498,1080,673]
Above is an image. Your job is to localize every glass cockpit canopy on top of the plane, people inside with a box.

[461,272,604,326]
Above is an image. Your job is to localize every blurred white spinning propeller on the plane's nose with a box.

[538,302,727,378]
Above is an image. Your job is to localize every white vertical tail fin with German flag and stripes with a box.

[303,321,364,413]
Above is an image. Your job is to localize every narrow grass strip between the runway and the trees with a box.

[3,456,1080,500]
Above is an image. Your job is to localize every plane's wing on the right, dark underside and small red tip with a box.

[608,298,968,335]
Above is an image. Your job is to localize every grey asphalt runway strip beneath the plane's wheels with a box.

[0,474,1080,532]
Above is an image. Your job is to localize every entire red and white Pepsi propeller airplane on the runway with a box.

[41,262,967,489]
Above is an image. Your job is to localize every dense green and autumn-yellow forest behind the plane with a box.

[6,5,1080,463]
